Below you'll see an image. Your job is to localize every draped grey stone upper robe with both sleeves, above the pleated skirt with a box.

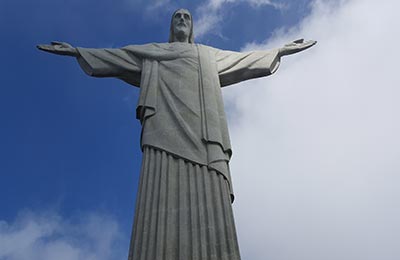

[77,42,280,258]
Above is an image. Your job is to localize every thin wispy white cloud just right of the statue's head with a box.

[194,0,284,38]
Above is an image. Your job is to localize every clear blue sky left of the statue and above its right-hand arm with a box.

[0,0,307,258]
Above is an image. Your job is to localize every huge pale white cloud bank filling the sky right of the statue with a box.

[225,0,400,260]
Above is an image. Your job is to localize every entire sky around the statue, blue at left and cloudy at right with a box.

[0,0,400,260]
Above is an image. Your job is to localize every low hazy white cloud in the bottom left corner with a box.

[0,211,128,260]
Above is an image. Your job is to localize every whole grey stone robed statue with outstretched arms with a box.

[38,9,316,260]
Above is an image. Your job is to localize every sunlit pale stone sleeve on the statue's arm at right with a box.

[215,49,280,87]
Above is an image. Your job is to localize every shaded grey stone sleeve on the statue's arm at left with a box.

[77,47,142,87]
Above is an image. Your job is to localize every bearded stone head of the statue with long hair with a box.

[168,9,194,43]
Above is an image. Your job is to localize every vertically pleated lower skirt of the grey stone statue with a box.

[128,146,240,260]
